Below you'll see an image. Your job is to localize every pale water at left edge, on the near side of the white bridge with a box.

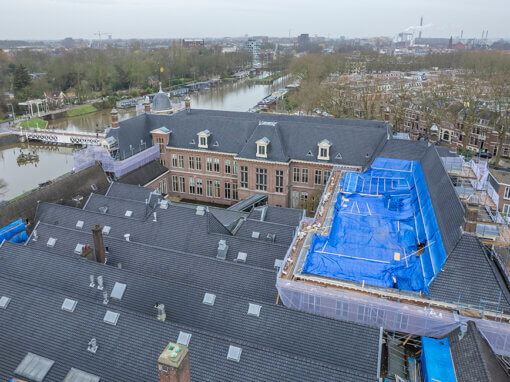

[0,142,74,201]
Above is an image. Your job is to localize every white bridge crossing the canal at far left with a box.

[13,129,105,146]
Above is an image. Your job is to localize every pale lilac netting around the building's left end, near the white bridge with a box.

[74,145,159,178]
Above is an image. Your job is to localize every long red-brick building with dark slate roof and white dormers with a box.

[105,110,391,207]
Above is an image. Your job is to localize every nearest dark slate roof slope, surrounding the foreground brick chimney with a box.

[0,276,376,382]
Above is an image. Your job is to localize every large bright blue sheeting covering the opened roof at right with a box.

[303,158,447,294]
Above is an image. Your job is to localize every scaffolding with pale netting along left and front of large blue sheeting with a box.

[276,168,510,356]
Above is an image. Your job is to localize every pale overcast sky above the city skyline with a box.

[0,0,510,40]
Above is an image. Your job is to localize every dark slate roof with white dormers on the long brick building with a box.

[108,109,390,167]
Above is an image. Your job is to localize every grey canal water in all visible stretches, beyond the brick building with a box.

[0,77,290,201]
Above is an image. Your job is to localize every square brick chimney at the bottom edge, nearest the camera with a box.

[158,342,190,382]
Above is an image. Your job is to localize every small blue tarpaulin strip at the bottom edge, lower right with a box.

[420,337,457,382]
